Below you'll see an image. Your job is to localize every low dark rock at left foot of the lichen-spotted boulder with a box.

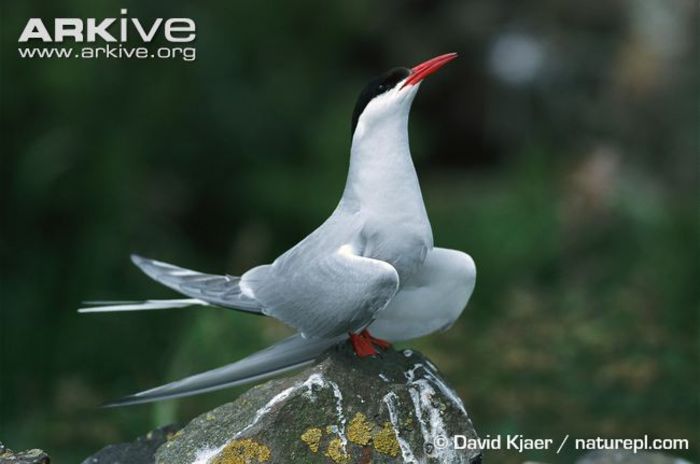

[83,425,179,464]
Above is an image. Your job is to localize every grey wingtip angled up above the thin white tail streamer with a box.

[131,255,262,314]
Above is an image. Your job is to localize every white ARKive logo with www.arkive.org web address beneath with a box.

[17,8,197,61]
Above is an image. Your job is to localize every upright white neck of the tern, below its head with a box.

[343,108,423,208]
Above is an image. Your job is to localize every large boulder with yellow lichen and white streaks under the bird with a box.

[156,345,481,464]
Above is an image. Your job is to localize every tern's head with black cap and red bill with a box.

[352,53,457,135]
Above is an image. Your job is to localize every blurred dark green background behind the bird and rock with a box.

[0,0,700,463]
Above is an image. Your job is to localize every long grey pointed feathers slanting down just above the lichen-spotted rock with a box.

[104,334,346,407]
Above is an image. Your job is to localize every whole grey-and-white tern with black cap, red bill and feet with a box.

[79,53,476,406]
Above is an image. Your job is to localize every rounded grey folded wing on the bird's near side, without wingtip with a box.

[242,245,399,338]
